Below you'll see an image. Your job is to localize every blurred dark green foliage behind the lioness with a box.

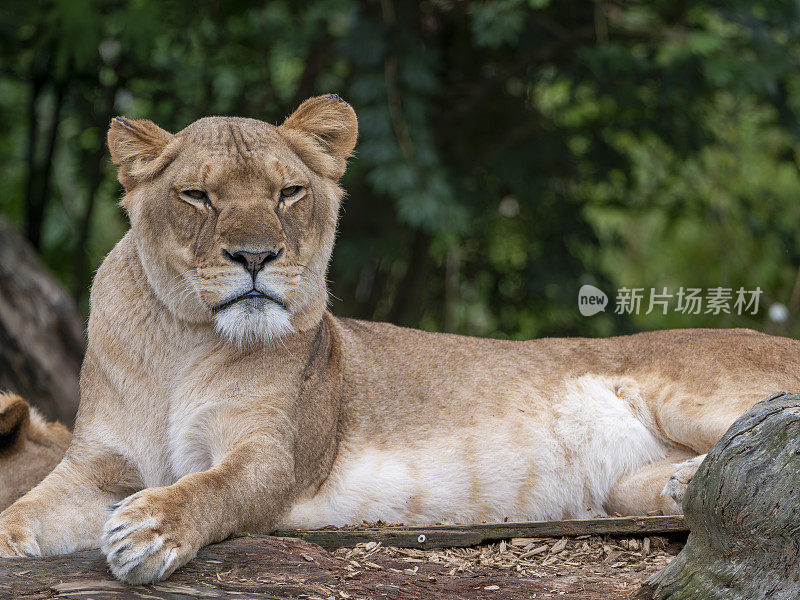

[0,0,800,338]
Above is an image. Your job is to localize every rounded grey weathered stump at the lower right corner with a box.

[639,393,800,600]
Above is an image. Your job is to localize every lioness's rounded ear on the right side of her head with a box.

[279,94,358,179]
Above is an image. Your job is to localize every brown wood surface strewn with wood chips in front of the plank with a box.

[0,536,685,600]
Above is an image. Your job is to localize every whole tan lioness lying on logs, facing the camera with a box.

[0,95,800,583]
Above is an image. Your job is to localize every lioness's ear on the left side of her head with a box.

[108,117,173,190]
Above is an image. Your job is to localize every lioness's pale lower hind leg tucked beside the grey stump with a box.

[604,450,700,515]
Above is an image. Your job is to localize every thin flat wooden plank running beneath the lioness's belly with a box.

[275,515,688,549]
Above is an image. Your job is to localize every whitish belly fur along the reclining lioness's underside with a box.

[280,376,669,528]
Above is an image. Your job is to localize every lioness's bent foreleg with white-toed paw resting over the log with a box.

[101,442,294,584]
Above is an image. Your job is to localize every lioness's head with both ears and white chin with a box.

[108,95,358,344]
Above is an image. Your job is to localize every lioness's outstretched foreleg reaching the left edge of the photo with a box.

[0,450,136,558]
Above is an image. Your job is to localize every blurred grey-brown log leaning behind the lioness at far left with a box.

[0,218,84,427]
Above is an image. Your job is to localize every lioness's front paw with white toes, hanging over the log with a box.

[101,488,200,584]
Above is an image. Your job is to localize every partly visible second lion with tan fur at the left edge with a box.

[0,394,71,511]
